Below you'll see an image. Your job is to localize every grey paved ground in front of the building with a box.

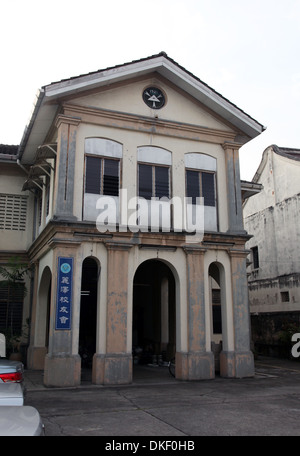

[25,358,300,438]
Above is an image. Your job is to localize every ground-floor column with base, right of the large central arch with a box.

[176,247,215,380]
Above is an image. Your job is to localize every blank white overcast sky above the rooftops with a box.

[0,0,300,180]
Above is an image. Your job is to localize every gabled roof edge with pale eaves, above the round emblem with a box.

[19,52,265,161]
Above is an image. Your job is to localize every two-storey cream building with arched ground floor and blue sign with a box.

[0,53,263,386]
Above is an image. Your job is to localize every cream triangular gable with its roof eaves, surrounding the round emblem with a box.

[19,52,264,163]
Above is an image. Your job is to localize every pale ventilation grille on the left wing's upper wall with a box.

[0,193,27,231]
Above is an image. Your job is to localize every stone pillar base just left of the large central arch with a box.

[92,354,132,385]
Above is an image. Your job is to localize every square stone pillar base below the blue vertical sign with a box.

[44,354,81,387]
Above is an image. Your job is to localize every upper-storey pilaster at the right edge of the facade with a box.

[223,143,246,234]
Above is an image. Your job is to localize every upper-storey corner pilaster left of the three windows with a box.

[53,114,80,220]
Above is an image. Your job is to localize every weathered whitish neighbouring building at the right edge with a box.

[243,145,300,354]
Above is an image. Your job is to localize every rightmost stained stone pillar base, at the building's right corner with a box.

[220,351,254,378]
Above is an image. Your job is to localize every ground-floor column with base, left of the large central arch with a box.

[93,242,132,385]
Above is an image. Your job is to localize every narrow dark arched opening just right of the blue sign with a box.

[79,257,99,375]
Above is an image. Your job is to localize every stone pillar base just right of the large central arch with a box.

[175,352,215,380]
